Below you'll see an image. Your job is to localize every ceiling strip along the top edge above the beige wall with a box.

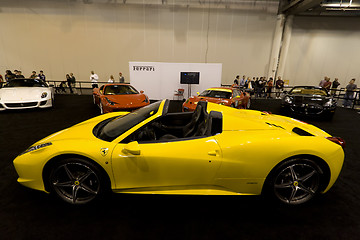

[0,0,360,17]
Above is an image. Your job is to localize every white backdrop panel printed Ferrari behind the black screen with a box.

[129,62,222,99]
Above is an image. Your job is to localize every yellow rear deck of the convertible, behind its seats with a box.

[208,103,330,137]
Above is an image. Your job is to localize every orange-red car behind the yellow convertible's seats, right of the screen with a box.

[183,87,250,112]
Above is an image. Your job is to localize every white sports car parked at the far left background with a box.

[0,79,54,111]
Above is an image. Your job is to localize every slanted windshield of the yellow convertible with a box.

[95,101,161,142]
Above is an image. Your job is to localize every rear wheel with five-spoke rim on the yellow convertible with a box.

[264,159,323,205]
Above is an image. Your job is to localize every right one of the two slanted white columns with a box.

[276,15,294,79]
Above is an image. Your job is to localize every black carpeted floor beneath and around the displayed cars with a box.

[0,95,360,240]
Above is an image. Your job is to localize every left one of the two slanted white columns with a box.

[267,14,285,78]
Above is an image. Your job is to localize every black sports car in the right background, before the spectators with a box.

[281,86,337,117]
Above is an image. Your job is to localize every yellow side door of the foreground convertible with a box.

[112,136,221,190]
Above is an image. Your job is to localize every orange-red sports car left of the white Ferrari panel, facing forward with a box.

[93,83,150,114]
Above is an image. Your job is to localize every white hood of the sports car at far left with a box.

[0,87,50,101]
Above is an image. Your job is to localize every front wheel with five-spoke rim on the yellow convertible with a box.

[47,158,109,205]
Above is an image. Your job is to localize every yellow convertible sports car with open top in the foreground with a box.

[14,100,344,205]
